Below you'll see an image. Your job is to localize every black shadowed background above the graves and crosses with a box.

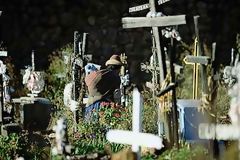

[0,0,240,81]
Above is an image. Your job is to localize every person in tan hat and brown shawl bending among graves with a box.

[85,55,123,117]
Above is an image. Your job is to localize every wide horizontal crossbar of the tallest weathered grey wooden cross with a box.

[122,15,186,28]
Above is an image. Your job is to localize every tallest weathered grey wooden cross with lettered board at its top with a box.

[122,0,186,146]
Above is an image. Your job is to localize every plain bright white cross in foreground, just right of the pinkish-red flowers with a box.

[106,88,163,159]
